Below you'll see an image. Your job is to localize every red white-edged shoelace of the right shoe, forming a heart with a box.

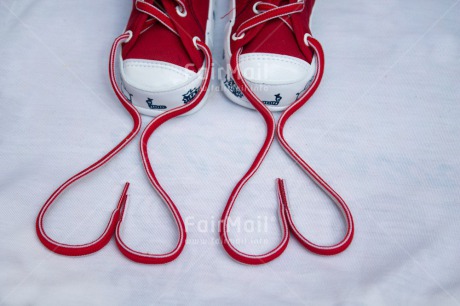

[220,1,354,265]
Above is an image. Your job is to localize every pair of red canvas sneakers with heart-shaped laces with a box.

[37,0,354,264]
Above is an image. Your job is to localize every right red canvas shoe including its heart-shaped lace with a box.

[220,0,354,264]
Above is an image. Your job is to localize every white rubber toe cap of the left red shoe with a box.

[120,59,204,116]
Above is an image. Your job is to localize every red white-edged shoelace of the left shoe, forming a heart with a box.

[36,0,212,264]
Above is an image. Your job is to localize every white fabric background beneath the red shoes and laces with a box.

[0,0,460,305]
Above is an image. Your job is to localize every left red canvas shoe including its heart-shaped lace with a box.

[36,0,214,264]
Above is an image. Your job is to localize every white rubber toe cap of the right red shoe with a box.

[230,53,315,111]
